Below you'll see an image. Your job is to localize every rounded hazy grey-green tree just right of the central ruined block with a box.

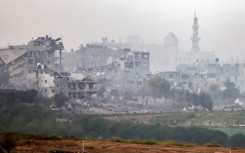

[148,76,170,100]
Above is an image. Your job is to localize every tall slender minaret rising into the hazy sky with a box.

[191,12,200,52]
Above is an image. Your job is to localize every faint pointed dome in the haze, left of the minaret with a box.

[164,32,178,49]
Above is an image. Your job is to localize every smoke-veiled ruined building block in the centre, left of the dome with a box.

[69,44,150,93]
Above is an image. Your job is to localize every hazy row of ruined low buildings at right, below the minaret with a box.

[159,58,245,92]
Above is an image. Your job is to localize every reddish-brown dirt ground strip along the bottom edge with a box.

[15,140,245,153]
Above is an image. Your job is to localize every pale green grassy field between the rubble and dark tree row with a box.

[105,111,245,136]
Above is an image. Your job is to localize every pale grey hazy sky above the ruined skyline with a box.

[0,0,245,59]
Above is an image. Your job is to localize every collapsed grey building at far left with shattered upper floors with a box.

[0,36,95,97]
